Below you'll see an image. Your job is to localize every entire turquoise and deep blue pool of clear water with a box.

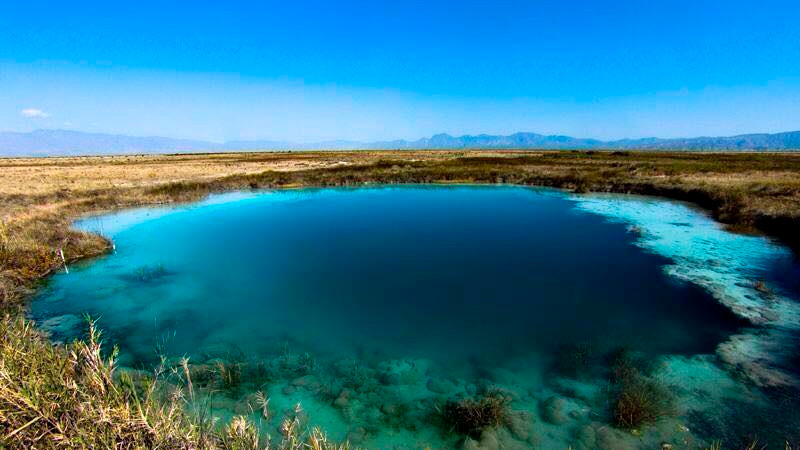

[31,186,800,448]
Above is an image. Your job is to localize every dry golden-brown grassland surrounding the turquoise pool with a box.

[0,150,800,448]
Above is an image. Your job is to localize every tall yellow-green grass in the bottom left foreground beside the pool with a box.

[0,316,354,450]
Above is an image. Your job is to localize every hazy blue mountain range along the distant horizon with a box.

[0,130,800,156]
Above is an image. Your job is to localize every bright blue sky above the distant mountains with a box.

[0,0,800,142]
